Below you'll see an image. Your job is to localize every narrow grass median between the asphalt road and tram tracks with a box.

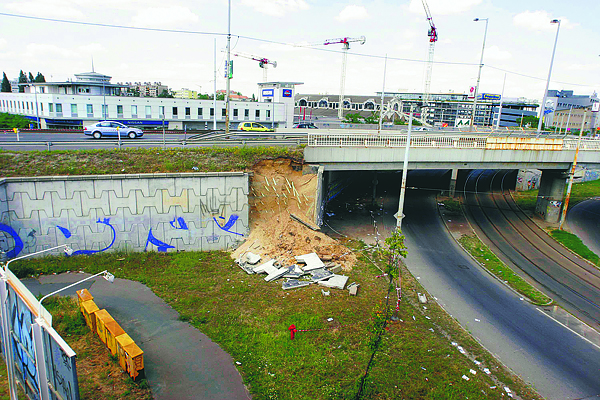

[459,235,551,305]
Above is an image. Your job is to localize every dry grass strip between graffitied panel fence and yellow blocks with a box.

[0,297,152,400]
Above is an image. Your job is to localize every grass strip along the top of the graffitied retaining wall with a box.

[0,147,303,177]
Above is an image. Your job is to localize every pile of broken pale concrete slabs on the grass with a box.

[235,252,360,296]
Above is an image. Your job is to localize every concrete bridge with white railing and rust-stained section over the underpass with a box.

[304,132,600,221]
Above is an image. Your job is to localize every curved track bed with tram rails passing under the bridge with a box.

[464,170,600,330]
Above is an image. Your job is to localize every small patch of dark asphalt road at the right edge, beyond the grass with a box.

[567,198,600,255]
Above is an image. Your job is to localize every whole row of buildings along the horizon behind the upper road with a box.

[0,72,600,131]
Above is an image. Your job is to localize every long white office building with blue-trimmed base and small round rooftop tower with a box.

[0,72,297,130]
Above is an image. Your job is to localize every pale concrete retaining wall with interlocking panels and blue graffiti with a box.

[0,172,249,258]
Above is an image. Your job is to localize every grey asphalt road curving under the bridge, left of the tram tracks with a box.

[328,172,600,400]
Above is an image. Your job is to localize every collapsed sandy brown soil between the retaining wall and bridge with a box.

[232,159,356,271]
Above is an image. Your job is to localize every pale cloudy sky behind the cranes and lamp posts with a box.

[0,0,600,100]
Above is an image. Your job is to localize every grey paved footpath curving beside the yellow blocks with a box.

[22,273,250,400]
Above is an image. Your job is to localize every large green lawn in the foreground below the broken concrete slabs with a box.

[11,243,539,399]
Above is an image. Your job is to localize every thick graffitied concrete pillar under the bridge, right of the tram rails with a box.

[535,169,568,222]
